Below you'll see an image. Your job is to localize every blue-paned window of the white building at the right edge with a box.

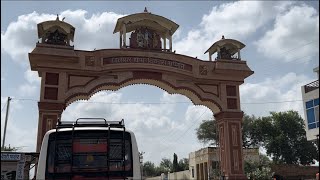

[306,98,319,129]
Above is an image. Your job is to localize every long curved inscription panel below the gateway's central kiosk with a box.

[103,56,192,71]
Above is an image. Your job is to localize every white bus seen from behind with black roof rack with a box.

[36,118,141,180]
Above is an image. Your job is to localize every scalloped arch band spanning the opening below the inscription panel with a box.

[65,57,222,113]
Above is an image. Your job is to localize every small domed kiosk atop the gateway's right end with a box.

[205,36,245,61]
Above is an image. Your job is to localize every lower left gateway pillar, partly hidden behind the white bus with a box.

[36,101,65,152]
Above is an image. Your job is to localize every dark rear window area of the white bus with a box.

[46,130,133,179]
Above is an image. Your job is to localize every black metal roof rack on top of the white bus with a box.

[56,118,124,129]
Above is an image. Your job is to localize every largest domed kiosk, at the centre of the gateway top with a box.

[113,8,179,52]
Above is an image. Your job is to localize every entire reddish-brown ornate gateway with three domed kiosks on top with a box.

[29,11,253,179]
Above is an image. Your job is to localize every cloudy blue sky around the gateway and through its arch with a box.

[1,1,319,167]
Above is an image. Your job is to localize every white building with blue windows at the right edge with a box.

[301,66,319,141]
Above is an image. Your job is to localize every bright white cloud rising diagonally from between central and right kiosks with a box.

[175,1,292,59]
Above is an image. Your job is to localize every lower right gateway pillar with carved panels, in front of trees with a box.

[214,111,247,180]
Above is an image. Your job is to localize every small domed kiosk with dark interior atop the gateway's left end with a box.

[37,15,75,46]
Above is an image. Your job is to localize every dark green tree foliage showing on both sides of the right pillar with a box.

[196,111,319,165]
